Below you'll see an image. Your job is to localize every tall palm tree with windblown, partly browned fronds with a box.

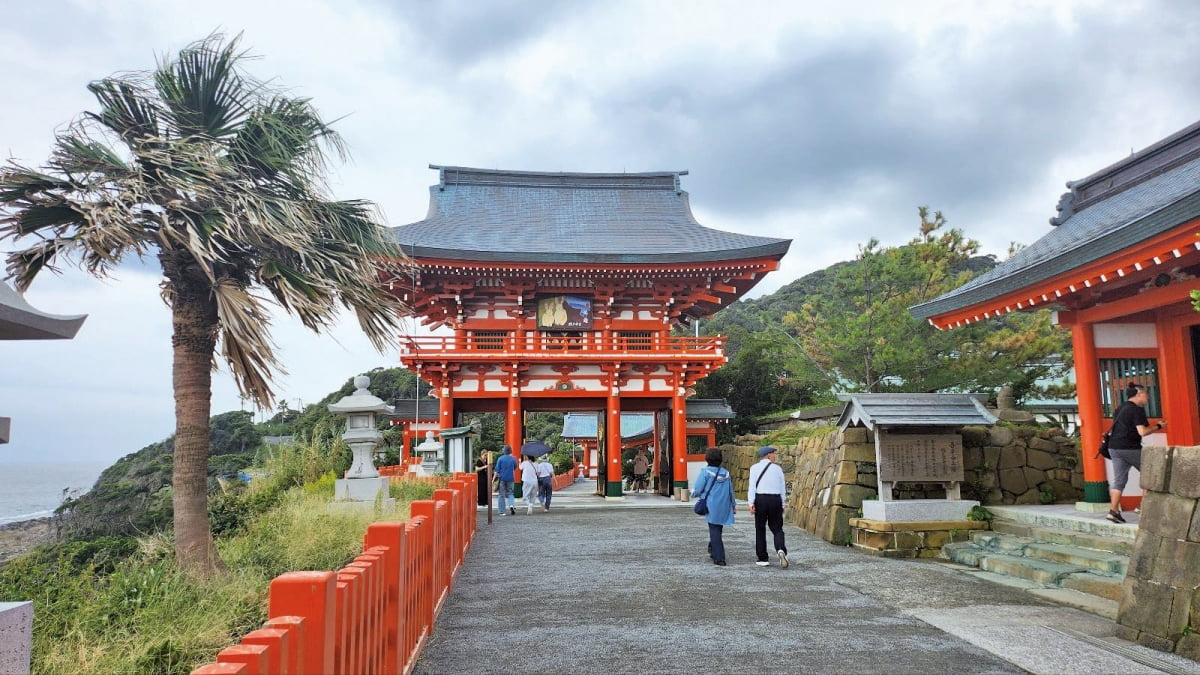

[0,35,408,575]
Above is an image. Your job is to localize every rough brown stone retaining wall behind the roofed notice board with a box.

[721,426,1084,544]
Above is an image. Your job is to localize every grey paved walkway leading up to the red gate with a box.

[416,483,1200,675]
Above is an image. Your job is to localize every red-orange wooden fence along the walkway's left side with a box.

[192,473,476,675]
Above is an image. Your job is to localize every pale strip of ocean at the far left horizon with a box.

[0,458,108,525]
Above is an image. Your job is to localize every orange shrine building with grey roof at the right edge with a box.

[912,123,1200,509]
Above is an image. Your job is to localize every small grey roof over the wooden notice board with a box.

[838,394,997,429]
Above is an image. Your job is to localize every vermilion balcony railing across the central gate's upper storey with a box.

[400,331,725,358]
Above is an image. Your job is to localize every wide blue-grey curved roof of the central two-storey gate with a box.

[391,165,791,264]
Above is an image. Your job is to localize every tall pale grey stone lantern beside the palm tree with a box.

[329,375,392,503]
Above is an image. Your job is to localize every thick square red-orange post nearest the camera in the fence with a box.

[266,572,335,675]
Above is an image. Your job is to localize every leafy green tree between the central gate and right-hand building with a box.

[784,207,1070,393]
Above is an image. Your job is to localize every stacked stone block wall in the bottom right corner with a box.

[1117,447,1200,661]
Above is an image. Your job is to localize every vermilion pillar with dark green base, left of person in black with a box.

[1070,322,1109,503]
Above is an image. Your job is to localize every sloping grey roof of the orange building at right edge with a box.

[911,123,1200,318]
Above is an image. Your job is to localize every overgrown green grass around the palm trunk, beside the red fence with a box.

[0,488,422,674]
